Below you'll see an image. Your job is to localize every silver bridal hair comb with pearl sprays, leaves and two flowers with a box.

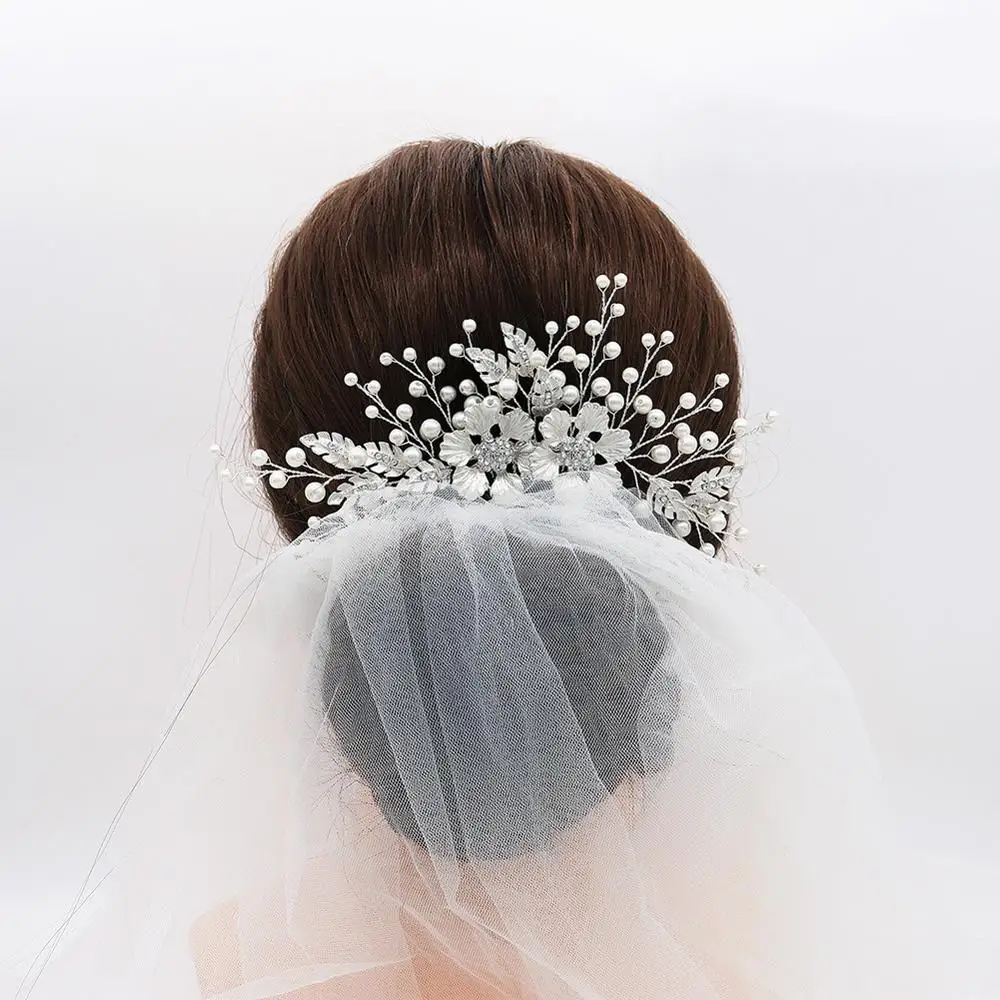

[219,274,777,555]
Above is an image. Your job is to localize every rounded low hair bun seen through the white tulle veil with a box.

[322,531,678,858]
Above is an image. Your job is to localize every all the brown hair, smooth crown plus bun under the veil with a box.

[252,140,739,858]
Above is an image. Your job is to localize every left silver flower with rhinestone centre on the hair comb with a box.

[438,403,535,500]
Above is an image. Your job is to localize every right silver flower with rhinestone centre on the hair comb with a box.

[532,403,632,479]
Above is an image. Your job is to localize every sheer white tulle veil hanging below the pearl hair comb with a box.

[17,476,1000,1000]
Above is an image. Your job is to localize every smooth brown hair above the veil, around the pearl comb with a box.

[251,139,740,538]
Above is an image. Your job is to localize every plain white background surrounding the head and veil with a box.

[0,0,1000,983]
